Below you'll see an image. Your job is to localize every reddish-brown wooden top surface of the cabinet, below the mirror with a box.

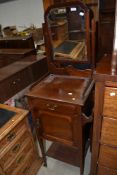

[27,74,93,105]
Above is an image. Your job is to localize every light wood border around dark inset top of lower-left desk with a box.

[0,104,28,141]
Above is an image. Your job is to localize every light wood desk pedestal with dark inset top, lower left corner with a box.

[0,104,42,175]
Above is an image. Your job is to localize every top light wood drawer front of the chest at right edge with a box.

[103,87,117,118]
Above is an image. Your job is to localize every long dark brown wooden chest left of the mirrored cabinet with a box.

[0,55,48,103]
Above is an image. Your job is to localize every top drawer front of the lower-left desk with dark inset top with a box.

[0,120,27,152]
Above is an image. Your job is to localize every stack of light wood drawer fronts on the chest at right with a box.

[97,87,117,175]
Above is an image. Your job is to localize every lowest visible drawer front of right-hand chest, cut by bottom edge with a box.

[97,166,117,175]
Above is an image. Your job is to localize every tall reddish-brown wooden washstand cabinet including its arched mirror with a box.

[27,1,95,175]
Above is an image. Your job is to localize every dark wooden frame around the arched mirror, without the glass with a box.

[43,0,95,74]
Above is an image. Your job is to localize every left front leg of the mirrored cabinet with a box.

[38,138,47,167]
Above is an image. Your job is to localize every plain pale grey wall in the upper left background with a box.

[0,0,44,30]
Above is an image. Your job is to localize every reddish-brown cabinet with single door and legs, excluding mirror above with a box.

[27,75,94,175]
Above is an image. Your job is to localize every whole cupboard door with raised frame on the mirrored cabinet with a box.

[33,110,80,146]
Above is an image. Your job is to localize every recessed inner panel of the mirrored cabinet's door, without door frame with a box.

[39,111,73,142]
